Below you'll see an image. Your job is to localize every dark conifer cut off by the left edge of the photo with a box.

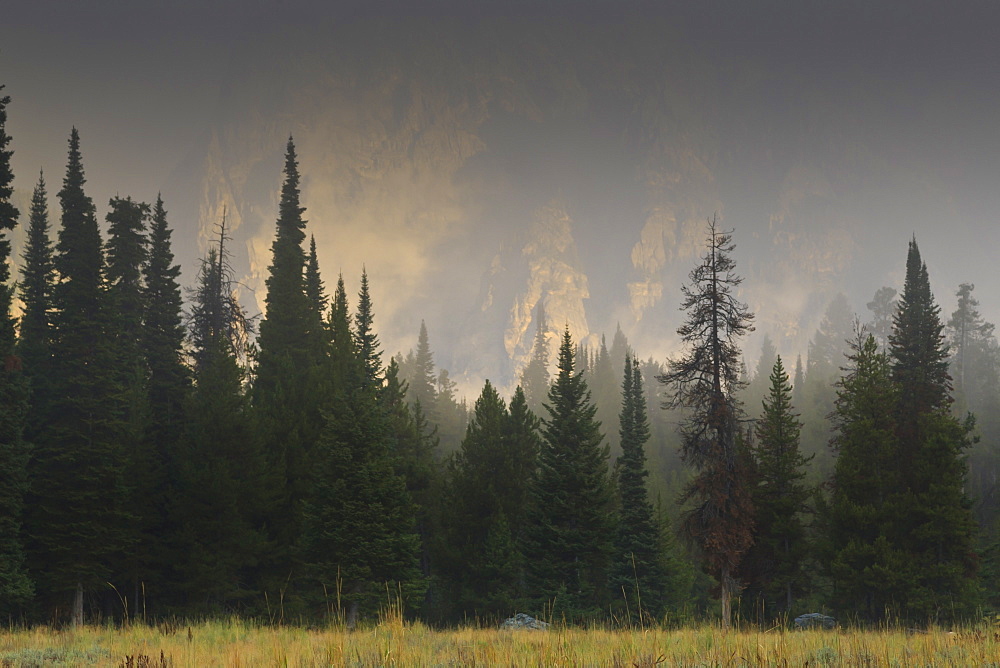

[0,86,32,618]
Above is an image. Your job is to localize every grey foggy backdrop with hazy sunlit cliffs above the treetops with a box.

[0,0,1000,396]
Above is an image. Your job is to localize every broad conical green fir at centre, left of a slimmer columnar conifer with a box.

[525,328,614,619]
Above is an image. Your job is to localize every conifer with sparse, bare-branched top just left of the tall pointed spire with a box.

[174,223,266,614]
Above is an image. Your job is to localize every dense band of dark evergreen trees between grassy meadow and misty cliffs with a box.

[0,87,1000,625]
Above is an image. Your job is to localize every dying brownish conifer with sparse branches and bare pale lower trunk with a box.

[659,219,753,628]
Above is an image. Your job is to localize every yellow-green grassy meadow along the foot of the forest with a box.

[0,620,1000,668]
